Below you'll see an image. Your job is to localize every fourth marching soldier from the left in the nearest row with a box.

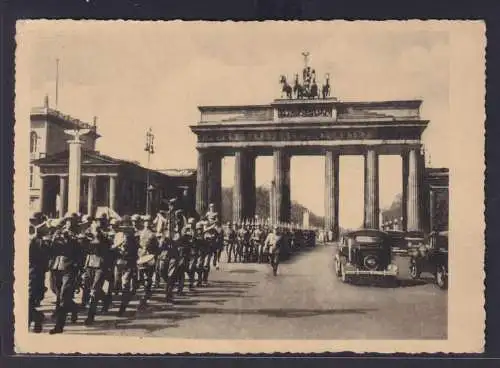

[111,216,139,316]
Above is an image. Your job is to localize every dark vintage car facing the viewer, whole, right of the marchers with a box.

[335,229,398,282]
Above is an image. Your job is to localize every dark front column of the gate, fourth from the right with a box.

[273,149,291,223]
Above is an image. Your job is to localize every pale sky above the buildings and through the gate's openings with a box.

[16,21,453,227]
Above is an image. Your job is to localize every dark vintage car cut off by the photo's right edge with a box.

[408,231,448,289]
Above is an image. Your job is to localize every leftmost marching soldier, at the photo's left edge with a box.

[28,213,49,333]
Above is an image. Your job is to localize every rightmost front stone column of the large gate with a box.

[407,149,421,231]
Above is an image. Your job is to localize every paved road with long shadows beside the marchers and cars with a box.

[37,245,447,339]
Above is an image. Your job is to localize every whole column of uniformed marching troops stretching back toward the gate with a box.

[29,199,315,334]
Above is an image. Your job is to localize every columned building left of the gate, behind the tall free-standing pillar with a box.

[30,98,196,217]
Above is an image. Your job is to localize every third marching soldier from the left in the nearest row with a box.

[83,219,111,325]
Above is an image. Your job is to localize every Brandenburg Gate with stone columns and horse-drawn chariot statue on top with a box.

[190,57,428,234]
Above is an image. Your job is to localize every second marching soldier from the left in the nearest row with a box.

[49,218,81,334]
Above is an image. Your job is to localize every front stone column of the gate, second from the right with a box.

[364,148,380,229]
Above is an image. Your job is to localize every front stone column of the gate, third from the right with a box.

[325,150,339,237]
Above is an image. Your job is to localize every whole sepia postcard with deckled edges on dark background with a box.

[14,20,486,353]
